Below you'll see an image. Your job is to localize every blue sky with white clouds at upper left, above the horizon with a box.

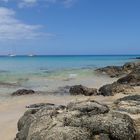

[0,0,140,55]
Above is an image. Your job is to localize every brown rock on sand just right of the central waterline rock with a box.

[98,82,134,96]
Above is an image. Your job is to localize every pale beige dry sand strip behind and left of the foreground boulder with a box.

[0,87,140,140]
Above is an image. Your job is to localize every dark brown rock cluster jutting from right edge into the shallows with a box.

[69,62,140,96]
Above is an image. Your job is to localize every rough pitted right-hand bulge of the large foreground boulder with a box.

[66,112,136,140]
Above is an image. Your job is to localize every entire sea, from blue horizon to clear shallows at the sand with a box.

[0,55,139,95]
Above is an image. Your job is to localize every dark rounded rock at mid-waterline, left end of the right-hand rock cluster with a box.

[69,85,97,96]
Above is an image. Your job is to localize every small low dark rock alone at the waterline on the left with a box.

[12,89,35,96]
